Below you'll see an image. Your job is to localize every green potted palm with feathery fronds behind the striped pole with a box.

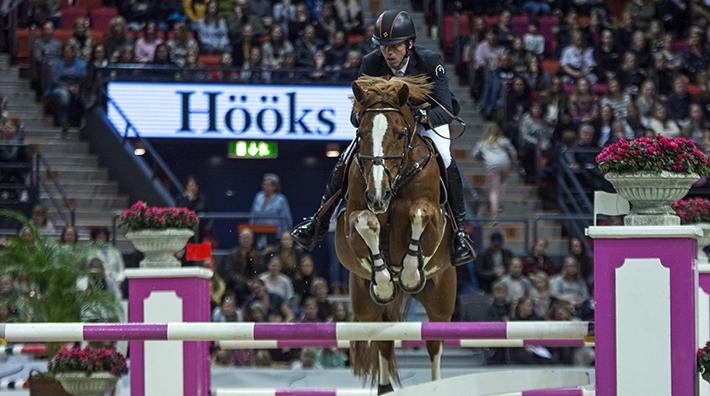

[0,210,121,396]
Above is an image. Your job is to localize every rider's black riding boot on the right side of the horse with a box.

[446,159,476,266]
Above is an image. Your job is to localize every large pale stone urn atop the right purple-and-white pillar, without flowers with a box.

[604,171,699,226]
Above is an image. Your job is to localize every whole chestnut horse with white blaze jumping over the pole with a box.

[335,76,456,394]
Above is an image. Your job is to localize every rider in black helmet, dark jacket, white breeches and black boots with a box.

[291,10,476,265]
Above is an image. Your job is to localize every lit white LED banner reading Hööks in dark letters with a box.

[108,82,355,141]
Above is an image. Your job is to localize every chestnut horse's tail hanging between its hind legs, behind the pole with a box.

[350,292,412,386]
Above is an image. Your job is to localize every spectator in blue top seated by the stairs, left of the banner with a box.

[45,43,86,138]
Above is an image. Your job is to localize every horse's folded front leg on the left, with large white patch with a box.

[350,210,396,304]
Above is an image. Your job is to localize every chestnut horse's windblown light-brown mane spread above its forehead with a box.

[354,74,434,113]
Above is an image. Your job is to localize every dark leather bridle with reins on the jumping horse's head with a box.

[355,101,434,195]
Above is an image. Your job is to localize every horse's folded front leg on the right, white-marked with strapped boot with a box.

[399,200,443,294]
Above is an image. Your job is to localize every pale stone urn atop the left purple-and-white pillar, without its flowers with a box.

[126,228,194,268]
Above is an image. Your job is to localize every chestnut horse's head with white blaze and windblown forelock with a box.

[352,76,431,214]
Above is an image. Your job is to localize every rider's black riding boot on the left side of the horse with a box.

[291,156,347,251]
